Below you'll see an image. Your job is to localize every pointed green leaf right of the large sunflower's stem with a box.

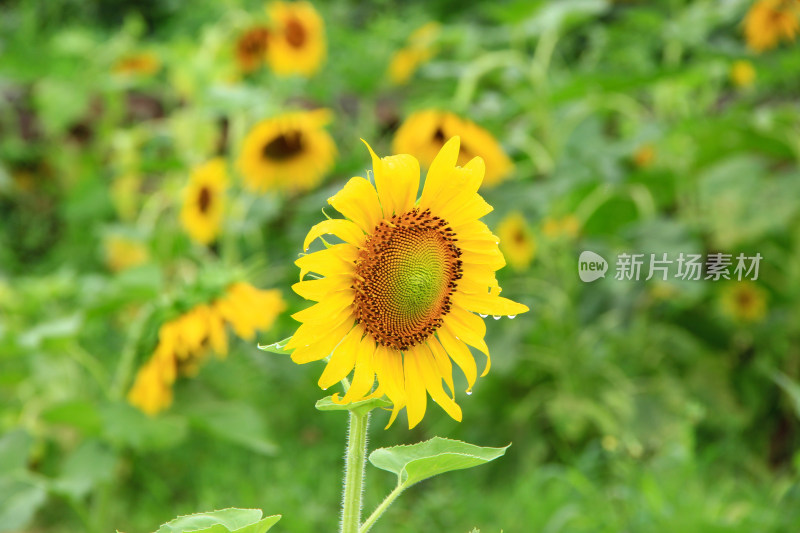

[369,437,511,487]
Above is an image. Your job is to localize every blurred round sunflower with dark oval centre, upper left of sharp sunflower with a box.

[238,109,336,192]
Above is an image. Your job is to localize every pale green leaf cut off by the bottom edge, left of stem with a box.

[156,508,281,533]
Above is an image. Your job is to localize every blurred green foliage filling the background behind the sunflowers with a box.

[0,0,800,533]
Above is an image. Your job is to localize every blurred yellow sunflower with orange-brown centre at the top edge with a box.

[267,2,327,76]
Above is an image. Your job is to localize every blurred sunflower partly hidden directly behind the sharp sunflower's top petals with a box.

[392,110,514,186]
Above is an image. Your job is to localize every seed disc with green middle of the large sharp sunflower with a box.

[353,208,461,350]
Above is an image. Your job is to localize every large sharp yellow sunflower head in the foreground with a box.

[286,137,528,427]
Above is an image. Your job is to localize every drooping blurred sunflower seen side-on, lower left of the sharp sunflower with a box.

[128,282,286,415]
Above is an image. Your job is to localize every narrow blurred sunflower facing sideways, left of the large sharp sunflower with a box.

[181,158,228,244]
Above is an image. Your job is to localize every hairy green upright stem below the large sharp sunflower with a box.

[341,409,369,533]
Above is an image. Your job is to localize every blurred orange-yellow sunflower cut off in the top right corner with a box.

[744,0,800,52]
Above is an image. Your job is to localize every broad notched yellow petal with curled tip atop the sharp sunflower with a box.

[361,139,419,218]
